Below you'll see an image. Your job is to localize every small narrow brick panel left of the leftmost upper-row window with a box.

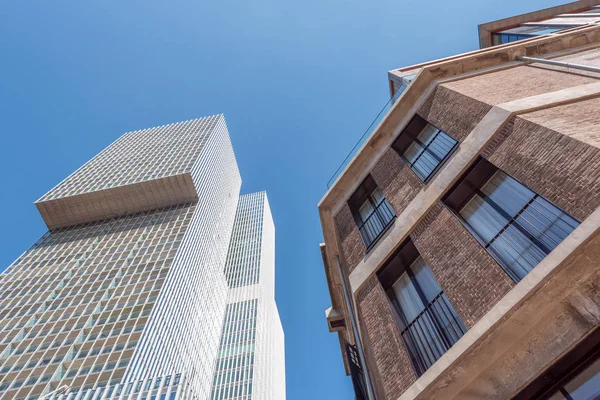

[333,203,365,275]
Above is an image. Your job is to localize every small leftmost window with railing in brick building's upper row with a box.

[348,175,396,250]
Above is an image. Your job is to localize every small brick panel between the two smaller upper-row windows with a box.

[371,149,423,219]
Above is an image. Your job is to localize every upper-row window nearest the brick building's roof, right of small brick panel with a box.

[392,115,458,182]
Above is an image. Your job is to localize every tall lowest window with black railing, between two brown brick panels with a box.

[377,240,466,376]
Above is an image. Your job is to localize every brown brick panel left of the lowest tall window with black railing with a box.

[356,277,417,400]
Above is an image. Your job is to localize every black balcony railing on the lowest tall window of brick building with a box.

[401,292,466,376]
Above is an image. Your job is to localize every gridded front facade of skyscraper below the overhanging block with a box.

[0,205,195,399]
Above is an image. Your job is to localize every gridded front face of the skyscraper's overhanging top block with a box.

[38,115,223,201]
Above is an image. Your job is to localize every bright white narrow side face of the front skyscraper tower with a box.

[126,124,241,398]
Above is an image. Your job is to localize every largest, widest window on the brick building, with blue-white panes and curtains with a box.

[445,158,579,282]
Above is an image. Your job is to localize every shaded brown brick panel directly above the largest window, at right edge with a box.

[482,115,600,220]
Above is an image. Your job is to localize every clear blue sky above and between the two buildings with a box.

[0,0,561,400]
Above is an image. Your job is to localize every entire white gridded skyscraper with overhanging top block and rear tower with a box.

[0,115,285,399]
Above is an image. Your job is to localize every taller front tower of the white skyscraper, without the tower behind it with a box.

[0,116,248,399]
